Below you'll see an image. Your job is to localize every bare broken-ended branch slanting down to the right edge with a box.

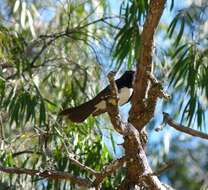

[163,112,208,140]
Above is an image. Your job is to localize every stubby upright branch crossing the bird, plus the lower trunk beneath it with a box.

[107,72,165,190]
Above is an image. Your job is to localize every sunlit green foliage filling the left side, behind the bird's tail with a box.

[0,0,117,189]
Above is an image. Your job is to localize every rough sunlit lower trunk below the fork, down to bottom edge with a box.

[121,123,165,190]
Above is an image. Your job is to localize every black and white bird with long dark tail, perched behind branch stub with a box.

[60,71,135,123]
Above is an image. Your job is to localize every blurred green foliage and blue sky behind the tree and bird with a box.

[0,0,208,189]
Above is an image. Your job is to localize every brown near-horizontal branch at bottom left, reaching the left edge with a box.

[0,165,91,187]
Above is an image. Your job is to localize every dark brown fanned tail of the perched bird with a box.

[60,100,96,123]
